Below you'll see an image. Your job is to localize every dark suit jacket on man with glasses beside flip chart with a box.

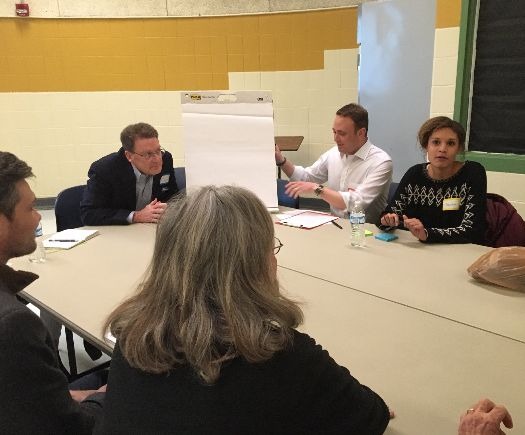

[80,148,178,225]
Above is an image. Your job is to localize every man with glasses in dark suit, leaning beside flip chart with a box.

[80,122,178,225]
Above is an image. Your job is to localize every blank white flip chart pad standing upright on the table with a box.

[181,91,278,208]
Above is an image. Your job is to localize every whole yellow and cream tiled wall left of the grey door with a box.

[0,8,358,197]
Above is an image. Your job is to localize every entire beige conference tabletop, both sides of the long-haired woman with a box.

[13,222,525,435]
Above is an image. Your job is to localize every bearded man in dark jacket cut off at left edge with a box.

[0,151,104,434]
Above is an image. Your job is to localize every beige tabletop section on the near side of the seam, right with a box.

[279,269,525,435]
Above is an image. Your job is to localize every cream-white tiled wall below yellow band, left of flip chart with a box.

[0,92,184,197]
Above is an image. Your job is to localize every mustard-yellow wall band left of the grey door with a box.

[0,8,357,92]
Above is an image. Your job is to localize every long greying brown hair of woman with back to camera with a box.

[105,186,303,384]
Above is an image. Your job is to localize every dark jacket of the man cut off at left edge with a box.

[0,264,104,435]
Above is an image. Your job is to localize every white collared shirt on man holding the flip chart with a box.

[290,141,392,223]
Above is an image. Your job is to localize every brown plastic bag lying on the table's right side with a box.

[467,246,525,292]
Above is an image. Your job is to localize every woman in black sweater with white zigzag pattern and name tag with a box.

[380,116,487,244]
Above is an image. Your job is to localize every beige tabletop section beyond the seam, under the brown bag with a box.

[275,219,525,343]
